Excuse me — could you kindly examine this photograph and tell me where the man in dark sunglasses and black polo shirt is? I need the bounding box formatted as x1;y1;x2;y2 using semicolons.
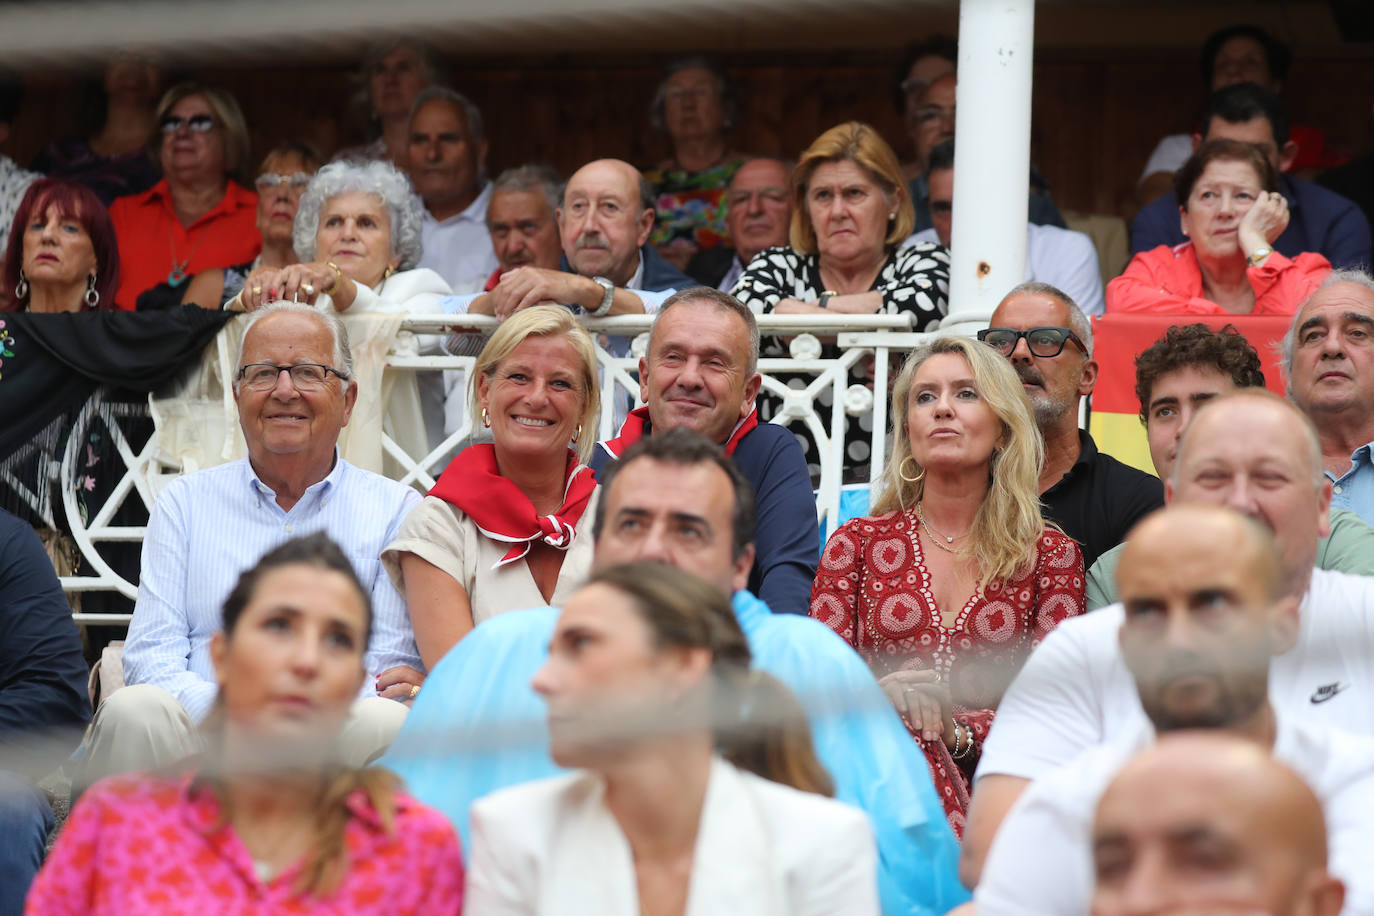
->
985;283;1164;567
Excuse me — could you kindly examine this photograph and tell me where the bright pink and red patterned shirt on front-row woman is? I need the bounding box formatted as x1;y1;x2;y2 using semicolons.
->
25;775;463;916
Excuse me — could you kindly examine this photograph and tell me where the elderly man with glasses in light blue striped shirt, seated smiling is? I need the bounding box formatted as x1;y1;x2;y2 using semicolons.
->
76;302;423;788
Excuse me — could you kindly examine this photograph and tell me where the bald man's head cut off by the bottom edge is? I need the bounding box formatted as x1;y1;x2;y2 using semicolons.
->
1092;732;1345;916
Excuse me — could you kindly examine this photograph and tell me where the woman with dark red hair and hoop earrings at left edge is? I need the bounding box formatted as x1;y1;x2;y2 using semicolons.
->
0;179;120;312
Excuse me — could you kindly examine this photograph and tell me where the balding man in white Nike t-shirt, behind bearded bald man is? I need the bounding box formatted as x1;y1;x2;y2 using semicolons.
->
960;389;1374;887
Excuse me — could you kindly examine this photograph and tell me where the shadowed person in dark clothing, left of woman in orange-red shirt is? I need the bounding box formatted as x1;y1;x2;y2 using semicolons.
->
30;54;162;206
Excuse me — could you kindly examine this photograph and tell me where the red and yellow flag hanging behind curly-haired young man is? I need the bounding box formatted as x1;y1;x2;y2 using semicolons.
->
1088;314;1292;474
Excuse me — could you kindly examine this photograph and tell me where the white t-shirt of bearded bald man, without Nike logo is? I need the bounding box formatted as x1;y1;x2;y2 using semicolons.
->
974;700;1374;916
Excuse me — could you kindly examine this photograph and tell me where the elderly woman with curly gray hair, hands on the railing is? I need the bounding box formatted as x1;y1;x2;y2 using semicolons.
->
239;162;452;313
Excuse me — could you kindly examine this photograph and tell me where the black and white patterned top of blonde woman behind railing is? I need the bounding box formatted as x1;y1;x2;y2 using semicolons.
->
731;242;949;483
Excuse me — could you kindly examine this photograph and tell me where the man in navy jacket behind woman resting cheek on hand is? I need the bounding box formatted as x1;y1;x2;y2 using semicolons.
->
1131;82;1370;269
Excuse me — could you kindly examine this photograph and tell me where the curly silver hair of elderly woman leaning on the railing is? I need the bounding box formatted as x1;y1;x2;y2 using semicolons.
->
291;161;425;271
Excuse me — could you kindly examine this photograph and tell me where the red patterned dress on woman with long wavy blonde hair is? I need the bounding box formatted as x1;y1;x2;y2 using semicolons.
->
811;512;1085;838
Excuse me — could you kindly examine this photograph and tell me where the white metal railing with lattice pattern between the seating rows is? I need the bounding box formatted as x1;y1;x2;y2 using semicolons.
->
45;314;934;623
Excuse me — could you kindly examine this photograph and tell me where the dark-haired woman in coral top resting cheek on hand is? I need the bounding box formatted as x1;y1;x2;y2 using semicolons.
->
1106;140;1331;314
